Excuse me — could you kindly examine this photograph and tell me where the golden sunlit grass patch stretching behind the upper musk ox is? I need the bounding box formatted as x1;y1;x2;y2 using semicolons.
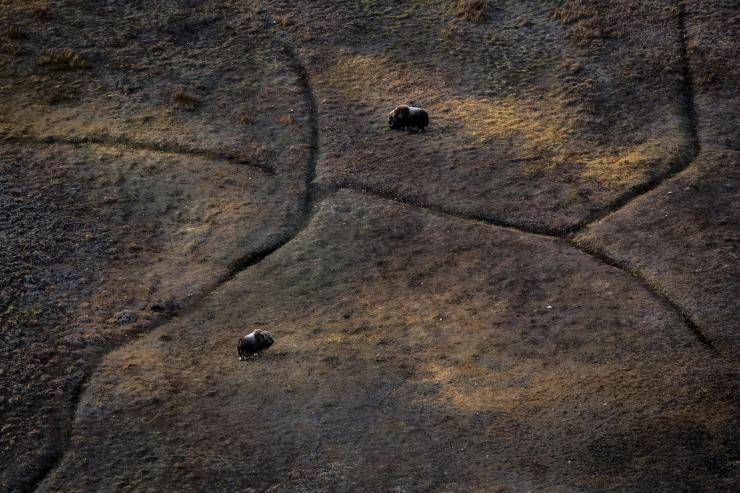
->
321;54;689;189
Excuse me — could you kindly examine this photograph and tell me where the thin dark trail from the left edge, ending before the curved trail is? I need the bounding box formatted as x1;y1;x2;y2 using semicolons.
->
0;135;275;175
